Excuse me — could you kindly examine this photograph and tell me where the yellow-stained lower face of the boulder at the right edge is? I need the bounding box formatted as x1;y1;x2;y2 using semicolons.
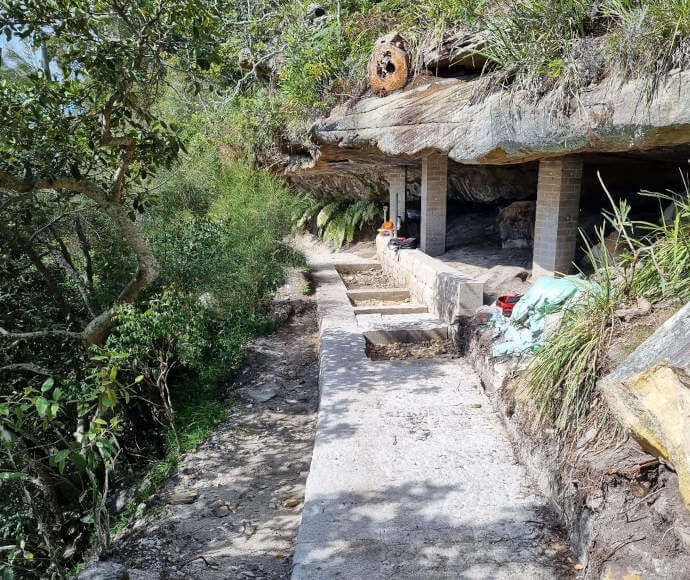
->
600;363;690;509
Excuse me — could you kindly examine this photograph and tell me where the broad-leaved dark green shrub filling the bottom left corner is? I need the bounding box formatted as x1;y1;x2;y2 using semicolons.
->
0;350;148;577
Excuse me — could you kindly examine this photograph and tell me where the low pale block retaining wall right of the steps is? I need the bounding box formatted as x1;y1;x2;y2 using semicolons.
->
376;236;483;324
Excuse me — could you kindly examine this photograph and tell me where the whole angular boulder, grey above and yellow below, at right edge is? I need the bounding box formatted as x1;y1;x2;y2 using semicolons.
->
599;304;690;509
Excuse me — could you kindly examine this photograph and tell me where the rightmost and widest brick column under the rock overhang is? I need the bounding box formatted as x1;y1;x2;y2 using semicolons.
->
532;157;582;278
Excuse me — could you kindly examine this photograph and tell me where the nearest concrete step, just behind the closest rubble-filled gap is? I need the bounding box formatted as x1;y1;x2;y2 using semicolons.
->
356;314;449;344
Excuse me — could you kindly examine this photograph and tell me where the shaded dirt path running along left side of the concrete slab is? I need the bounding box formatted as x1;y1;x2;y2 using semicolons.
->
109;284;318;579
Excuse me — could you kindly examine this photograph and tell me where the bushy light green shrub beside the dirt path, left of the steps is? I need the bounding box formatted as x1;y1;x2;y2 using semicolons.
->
100;153;304;540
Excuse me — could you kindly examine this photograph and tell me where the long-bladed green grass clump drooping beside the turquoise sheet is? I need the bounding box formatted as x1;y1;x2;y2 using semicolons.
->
520;178;690;434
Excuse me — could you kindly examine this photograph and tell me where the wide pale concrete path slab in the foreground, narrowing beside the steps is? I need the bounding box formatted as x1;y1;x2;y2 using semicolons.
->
292;251;568;580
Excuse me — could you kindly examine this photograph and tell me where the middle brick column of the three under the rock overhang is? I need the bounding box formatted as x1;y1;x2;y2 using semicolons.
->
419;153;448;256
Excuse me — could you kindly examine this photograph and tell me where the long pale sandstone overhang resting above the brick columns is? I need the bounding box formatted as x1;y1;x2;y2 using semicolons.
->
296;71;690;174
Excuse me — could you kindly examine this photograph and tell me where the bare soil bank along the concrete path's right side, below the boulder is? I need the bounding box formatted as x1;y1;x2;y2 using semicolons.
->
463;309;690;580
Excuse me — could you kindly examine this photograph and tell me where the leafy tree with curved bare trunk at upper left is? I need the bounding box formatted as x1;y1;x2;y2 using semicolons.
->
0;0;220;343
